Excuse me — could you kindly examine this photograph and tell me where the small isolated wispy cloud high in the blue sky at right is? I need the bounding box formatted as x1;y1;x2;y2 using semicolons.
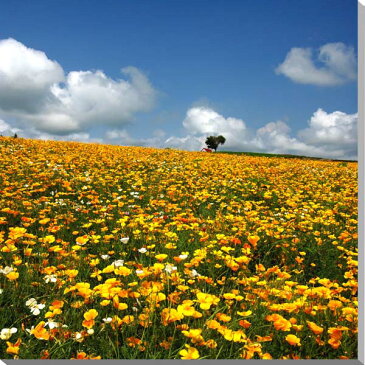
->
275;42;357;86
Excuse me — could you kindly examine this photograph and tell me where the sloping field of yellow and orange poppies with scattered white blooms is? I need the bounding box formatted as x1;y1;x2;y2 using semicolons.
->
0;137;358;359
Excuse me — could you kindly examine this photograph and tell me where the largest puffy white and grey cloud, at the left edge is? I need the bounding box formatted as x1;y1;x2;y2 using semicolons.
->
0;39;156;135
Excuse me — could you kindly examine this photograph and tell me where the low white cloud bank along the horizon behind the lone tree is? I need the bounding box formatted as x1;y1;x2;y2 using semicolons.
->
163;107;357;159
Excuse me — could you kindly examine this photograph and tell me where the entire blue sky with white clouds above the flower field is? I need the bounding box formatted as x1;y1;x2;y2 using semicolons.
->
0;0;357;159
